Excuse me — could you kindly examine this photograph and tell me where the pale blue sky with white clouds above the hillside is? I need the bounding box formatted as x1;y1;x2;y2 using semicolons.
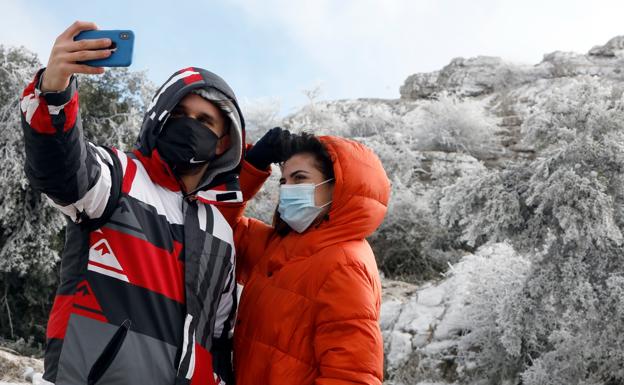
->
0;0;624;115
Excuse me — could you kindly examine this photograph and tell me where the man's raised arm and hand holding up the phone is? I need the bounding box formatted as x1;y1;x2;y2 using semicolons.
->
20;22;118;222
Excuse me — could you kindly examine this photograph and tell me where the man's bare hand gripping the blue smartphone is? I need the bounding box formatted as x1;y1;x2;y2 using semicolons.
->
41;21;112;92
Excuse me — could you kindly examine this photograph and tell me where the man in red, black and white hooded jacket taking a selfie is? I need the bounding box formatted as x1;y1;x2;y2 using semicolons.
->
21;22;244;385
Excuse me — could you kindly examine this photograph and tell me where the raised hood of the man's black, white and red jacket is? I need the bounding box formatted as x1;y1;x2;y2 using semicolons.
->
136;67;245;189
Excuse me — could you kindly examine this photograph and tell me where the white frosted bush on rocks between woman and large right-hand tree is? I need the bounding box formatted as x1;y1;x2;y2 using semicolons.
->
449;243;531;385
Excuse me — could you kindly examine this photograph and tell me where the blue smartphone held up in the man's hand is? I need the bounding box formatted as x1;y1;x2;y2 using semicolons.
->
74;30;134;67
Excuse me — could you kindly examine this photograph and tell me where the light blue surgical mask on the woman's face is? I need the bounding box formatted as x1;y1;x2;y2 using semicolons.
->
277;178;333;233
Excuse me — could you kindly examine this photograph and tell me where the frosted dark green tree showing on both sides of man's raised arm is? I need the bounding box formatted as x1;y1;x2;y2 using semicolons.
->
0;46;154;342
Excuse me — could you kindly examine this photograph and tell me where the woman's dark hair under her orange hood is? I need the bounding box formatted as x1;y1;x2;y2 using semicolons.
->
273;132;334;237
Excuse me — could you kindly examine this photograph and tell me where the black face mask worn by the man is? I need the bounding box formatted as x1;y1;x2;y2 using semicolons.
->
156;116;220;173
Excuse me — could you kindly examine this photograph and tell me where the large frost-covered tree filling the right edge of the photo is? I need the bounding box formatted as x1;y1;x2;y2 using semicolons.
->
440;77;624;385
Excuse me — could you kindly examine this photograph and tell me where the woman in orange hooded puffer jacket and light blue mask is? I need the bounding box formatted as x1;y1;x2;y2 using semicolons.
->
224;128;390;385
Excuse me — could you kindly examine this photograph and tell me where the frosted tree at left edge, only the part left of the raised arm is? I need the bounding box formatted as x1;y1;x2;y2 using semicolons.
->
0;46;63;344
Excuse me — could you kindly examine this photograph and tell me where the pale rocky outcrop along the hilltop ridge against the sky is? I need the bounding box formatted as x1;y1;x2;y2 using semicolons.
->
400;36;624;167
